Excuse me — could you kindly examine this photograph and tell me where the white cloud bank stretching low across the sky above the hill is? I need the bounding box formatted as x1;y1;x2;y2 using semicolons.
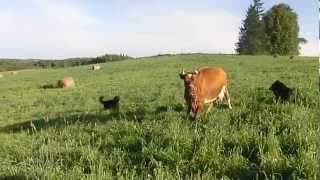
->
0;0;318;58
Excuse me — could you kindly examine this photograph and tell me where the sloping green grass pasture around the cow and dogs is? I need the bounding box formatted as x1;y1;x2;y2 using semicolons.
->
0;54;319;179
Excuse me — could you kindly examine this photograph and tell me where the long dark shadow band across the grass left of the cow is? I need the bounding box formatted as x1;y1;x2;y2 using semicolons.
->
0;103;238;134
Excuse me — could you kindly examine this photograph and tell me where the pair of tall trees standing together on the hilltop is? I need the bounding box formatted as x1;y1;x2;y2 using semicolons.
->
236;0;307;56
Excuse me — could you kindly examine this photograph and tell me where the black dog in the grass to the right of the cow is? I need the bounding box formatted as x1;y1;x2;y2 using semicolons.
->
269;80;293;101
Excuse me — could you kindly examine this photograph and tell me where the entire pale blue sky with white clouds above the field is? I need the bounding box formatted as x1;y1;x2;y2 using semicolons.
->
0;0;319;59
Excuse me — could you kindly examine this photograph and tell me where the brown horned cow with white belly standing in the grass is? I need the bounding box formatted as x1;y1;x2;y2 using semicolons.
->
179;67;232;118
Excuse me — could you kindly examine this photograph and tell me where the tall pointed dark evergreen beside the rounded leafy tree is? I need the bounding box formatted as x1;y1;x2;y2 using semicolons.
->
236;0;266;54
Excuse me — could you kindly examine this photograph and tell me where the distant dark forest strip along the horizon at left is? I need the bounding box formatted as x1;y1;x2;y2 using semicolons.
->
0;54;133;72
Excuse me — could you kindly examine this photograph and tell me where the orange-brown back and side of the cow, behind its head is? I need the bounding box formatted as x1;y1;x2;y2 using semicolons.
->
196;67;228;99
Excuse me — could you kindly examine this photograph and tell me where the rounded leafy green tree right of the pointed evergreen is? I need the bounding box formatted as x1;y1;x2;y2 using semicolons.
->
263;4;299;55
